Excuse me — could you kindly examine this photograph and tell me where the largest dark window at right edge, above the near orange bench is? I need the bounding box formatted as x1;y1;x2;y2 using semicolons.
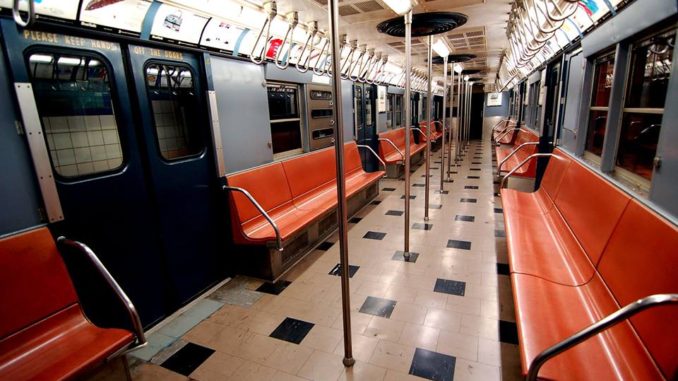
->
615;29;676;184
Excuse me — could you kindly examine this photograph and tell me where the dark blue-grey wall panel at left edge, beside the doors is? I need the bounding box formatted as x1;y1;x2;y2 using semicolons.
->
0;40;41;236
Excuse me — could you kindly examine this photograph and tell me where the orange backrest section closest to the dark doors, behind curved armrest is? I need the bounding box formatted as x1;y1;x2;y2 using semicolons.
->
226;163;292;224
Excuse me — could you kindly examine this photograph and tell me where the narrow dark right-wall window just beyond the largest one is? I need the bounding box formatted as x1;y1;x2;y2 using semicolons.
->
585;53;614;156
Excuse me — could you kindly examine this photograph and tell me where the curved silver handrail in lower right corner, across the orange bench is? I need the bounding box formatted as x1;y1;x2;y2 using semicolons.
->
526;294;678;381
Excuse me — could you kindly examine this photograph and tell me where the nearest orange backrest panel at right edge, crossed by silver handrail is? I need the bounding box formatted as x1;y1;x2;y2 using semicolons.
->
598;200;678;380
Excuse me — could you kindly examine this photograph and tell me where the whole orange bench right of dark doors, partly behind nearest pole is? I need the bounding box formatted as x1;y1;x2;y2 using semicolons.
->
227;142;384;244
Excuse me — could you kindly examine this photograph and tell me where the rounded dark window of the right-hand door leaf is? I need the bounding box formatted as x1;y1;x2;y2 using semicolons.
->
146;63;203;160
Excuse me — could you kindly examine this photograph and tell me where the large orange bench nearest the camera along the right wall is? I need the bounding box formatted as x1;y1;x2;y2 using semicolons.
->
501;149;678;380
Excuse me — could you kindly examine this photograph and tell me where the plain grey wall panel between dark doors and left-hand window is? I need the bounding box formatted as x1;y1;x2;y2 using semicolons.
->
211;56;273;173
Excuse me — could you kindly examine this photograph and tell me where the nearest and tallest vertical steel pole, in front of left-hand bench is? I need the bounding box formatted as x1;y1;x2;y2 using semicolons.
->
327;0;355;367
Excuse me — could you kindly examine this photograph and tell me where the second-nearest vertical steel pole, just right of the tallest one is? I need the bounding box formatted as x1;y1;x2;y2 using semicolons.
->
404;11;412;255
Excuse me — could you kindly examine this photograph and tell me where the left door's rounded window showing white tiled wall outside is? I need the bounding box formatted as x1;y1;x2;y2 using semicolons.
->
28;52;123;177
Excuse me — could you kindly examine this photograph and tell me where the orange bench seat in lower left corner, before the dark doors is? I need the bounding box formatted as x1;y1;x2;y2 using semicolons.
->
0;227;134;380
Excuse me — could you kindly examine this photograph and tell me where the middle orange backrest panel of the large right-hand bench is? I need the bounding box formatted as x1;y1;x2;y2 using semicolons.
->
554;160;630;265
